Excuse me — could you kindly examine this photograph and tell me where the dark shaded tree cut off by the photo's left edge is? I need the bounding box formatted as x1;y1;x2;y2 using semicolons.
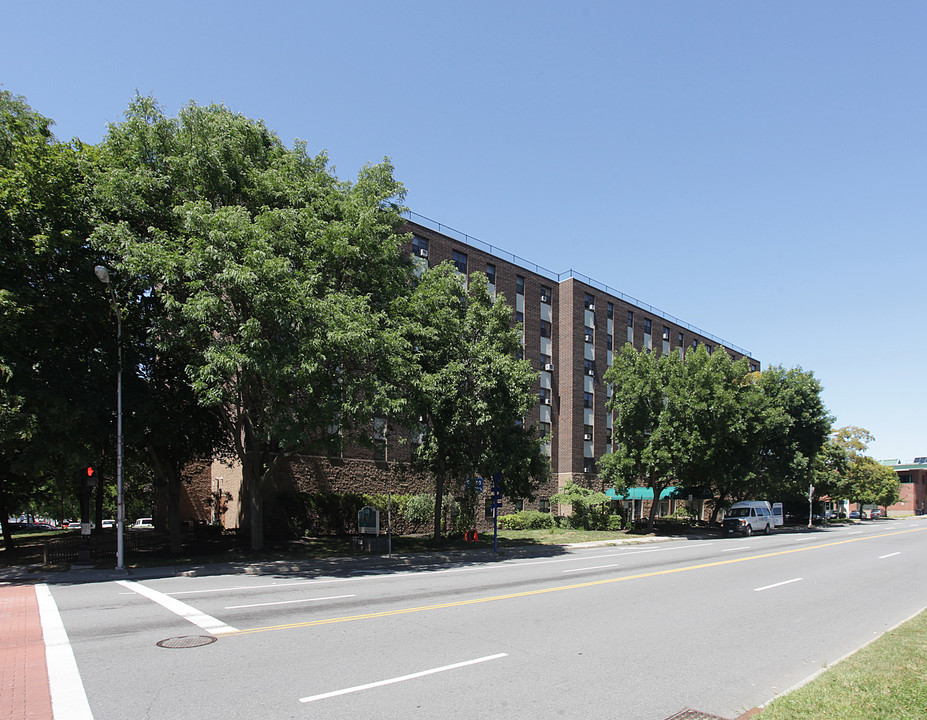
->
0;91;109;541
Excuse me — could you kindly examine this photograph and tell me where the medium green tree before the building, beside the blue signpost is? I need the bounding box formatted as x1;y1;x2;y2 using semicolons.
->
402;263;550;541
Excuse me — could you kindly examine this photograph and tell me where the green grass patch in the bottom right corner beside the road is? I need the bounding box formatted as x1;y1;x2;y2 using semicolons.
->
759;611;927;720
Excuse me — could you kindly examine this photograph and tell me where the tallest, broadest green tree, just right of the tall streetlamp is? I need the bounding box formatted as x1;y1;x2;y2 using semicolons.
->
96;98;411;549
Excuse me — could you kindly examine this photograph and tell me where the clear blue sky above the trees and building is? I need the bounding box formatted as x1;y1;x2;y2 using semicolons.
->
0;0;927;460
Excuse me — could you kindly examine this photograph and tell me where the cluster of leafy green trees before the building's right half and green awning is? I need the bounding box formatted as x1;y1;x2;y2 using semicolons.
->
600;344;830;524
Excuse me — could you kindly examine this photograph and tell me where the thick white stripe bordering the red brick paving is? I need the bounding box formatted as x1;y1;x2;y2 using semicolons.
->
35;583;93;720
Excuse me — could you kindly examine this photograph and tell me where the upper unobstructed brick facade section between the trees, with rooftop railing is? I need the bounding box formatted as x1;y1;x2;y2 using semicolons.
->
408;214;760;510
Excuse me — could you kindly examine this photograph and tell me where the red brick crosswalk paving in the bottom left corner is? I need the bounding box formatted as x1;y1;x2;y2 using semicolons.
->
0;584;53;720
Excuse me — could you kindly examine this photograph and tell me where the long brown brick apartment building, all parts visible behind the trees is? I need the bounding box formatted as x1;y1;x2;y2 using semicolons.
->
203;213;759;527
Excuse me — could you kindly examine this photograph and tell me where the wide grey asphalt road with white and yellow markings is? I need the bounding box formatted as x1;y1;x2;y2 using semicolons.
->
50;518;927;720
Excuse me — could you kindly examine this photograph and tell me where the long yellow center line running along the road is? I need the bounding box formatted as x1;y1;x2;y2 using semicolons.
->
214;528;927;637
